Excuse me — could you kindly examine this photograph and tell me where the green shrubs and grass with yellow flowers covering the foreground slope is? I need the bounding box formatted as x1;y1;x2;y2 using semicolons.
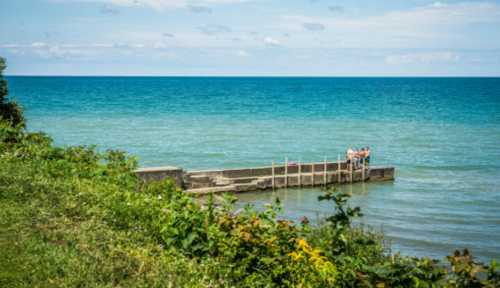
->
0;58;500;287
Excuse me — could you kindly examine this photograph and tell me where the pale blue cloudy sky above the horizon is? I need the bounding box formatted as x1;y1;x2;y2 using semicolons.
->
0;0;500;76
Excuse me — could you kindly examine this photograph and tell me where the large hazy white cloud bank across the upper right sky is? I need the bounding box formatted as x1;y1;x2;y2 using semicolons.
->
280;2;500;50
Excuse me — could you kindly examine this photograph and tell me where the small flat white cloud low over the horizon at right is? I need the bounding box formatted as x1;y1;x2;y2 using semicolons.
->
385;51;460;65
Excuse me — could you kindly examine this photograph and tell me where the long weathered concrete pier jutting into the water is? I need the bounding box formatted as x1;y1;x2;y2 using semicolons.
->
137;162;395;195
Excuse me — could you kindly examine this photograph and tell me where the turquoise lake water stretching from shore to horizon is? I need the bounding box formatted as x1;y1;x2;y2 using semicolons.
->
8;77;500;260
